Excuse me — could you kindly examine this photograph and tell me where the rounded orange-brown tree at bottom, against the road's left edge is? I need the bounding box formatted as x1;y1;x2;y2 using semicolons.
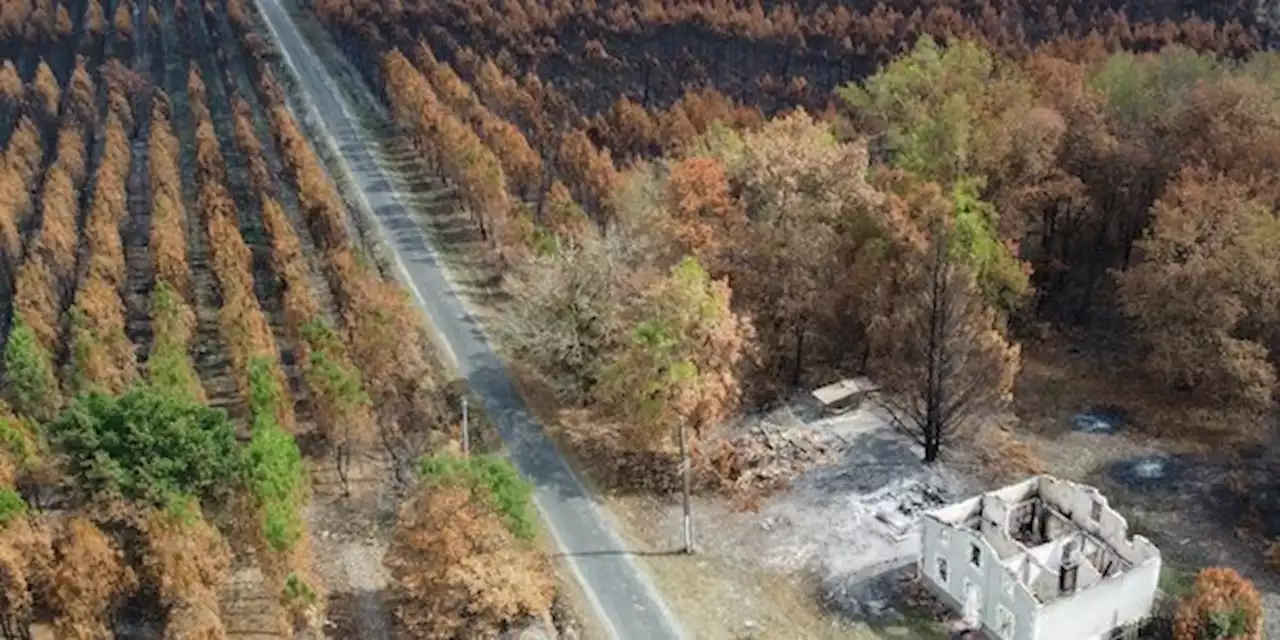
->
384;486;554;639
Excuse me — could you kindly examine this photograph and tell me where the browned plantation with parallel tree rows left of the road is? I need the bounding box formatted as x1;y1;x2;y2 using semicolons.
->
0;0;529;639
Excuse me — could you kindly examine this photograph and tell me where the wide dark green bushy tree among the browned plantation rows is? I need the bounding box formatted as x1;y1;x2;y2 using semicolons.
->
50;388;241;507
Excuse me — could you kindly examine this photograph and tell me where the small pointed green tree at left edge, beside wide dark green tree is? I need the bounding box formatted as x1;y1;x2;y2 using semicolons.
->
4;314;60;420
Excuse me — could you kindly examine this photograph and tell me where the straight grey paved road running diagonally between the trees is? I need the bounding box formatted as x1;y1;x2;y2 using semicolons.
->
250;0;684;640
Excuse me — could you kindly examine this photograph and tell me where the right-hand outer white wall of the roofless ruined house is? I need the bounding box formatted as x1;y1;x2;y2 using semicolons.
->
1034;557;1160;640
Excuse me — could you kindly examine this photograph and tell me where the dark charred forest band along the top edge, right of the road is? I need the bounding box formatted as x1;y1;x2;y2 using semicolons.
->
315;0;1274;120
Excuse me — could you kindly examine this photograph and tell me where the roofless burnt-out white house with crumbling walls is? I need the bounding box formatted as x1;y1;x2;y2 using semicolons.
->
918;476;1160;640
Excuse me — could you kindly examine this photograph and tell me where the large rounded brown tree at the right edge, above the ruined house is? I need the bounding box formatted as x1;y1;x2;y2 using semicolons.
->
1119;172;1280;408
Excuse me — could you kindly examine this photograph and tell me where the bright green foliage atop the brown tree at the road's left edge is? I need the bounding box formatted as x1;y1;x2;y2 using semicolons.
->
417;453;538;540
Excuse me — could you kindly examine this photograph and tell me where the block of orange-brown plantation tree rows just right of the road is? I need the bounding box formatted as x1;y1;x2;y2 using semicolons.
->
380;41;763;243
